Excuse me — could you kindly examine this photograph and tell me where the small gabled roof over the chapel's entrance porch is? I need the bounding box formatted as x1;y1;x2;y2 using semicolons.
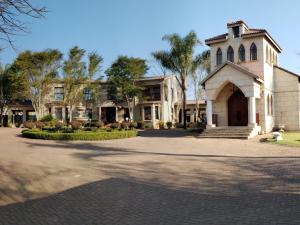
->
200;61;263;85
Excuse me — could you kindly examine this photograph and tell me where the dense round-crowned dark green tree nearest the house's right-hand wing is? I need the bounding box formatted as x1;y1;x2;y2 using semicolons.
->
106;56;148;120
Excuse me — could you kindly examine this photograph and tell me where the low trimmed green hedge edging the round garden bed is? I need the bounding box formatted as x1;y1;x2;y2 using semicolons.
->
22;129;138;141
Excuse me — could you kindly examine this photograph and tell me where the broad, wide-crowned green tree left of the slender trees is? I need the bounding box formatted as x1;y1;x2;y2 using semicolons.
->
8;49;62;120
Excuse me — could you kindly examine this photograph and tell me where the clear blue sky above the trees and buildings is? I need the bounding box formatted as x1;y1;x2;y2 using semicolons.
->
0;0;300;78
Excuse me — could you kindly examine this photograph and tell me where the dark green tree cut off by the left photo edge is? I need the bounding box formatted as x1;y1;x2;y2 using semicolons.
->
0;65;11;125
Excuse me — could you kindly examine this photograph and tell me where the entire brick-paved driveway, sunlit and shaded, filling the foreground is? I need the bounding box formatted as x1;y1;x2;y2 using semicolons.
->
0;129;300;225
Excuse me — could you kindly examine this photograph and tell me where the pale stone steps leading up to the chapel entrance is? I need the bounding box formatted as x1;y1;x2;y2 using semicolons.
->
199;126;260;139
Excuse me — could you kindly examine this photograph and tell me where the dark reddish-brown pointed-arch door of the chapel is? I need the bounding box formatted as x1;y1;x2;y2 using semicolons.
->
227;89;248;126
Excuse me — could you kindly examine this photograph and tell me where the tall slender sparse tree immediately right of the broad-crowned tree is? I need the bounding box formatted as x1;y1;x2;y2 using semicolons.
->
63;46;88;121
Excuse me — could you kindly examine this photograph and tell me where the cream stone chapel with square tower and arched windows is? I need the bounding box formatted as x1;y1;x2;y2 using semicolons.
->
201;21;300;136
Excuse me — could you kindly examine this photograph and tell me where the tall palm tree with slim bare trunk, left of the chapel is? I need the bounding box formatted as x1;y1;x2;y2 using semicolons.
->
153;31;201;129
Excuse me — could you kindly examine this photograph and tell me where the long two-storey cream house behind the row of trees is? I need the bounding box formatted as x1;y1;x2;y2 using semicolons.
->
5;75;181;128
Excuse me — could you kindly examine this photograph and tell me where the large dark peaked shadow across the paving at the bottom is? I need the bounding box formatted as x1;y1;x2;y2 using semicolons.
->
0;179;300;225
